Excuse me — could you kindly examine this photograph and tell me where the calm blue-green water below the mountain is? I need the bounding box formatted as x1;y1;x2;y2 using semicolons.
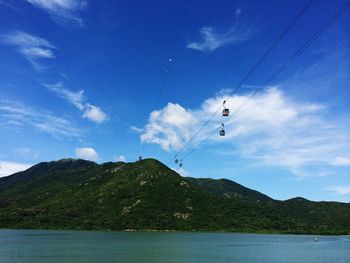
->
0;230;350;263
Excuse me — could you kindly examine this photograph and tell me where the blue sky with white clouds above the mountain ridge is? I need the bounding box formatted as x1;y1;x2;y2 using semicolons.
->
0;0;350;202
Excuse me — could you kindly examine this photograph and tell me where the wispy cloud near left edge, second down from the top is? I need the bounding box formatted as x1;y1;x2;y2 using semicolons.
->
0;31;55;70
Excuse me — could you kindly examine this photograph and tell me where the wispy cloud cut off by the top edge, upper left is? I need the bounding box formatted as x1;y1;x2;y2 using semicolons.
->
26;0;87;27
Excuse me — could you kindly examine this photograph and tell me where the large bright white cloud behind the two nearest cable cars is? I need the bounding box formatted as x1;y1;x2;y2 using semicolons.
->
141;88;350;176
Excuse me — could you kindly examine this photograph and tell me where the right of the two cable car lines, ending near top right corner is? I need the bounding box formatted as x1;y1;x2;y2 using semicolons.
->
178;0;350;163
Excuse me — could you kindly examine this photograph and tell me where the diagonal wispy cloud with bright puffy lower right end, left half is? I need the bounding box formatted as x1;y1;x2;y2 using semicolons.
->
44;82;109;123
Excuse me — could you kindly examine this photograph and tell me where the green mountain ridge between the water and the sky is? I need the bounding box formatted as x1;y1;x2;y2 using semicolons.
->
0;159;350;234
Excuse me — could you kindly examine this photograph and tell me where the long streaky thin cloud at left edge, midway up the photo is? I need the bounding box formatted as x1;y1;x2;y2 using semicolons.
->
0;100;80;138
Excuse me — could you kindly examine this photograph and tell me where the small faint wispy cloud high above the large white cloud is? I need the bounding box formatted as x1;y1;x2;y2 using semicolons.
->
187;27;250;52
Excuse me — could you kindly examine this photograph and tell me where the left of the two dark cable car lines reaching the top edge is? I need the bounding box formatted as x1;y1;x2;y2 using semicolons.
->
167;0;315;167
